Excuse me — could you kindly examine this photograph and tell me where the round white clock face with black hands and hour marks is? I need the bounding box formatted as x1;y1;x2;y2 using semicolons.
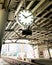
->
18;10;34;27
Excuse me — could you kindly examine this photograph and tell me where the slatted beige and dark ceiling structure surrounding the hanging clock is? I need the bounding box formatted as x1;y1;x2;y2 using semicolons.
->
0;0;52;44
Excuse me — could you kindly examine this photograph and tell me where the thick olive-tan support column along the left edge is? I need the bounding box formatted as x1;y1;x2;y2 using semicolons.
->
0;9;8;53
